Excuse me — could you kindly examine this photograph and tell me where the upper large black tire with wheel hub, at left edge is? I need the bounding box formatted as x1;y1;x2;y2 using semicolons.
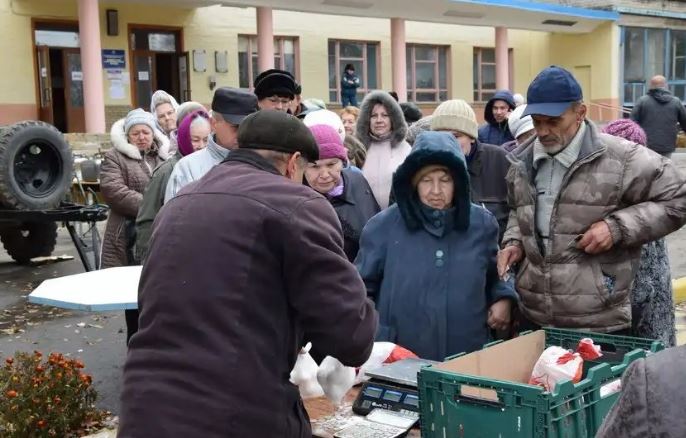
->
0;121;73;210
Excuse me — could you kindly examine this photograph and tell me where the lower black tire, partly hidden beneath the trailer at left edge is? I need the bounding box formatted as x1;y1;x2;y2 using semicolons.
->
0;222;57;264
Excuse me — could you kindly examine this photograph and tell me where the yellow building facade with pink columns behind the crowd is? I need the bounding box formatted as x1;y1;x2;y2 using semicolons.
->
0;0;636;132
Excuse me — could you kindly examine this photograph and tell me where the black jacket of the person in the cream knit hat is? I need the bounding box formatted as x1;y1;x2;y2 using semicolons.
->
467;141;510;242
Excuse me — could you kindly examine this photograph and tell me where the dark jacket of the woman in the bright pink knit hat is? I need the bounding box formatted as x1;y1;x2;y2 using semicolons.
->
331;169;381;262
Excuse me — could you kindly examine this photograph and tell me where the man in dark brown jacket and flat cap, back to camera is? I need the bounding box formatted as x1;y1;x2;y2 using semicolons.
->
118;110;377;438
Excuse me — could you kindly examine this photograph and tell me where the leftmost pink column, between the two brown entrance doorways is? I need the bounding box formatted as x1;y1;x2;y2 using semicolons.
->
79;0;106;133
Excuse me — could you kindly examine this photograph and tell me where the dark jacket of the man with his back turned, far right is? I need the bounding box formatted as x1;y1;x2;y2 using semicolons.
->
631;88;686;154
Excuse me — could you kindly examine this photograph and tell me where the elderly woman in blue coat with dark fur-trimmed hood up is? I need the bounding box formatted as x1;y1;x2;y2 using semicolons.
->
355;132;517;360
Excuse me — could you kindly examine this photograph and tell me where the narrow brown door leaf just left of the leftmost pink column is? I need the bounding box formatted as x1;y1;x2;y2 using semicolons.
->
63;49;86;132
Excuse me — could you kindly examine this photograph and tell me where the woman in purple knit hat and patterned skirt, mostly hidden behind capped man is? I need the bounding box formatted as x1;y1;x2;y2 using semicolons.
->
603;119;676;347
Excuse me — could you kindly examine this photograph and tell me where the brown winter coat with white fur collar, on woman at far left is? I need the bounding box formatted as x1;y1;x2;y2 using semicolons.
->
100;119;169;268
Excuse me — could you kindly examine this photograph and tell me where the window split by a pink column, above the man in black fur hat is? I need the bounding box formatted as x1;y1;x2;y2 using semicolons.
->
238;35;300;90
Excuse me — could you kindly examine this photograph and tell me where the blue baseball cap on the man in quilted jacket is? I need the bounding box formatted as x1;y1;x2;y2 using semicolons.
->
522;65;583;117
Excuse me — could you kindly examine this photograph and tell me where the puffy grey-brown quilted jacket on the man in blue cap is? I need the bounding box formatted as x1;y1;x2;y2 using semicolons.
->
503;121;686;332
